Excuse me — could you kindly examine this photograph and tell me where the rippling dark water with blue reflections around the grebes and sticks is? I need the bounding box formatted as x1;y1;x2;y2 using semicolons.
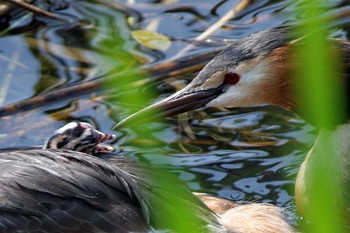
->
0;0;347;228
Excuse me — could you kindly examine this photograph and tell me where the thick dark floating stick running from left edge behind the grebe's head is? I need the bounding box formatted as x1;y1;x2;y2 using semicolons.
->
0;47;223;117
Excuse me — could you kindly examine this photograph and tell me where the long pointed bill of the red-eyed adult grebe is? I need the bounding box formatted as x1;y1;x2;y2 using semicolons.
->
113;86;223;129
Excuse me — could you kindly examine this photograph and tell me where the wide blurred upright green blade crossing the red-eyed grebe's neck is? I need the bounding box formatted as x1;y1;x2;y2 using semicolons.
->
295;0;345;233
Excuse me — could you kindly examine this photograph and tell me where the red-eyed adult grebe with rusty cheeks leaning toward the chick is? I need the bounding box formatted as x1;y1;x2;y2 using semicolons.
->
115;27;350;224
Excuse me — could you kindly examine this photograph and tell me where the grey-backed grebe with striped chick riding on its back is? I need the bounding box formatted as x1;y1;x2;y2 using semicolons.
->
0;122;293;233
